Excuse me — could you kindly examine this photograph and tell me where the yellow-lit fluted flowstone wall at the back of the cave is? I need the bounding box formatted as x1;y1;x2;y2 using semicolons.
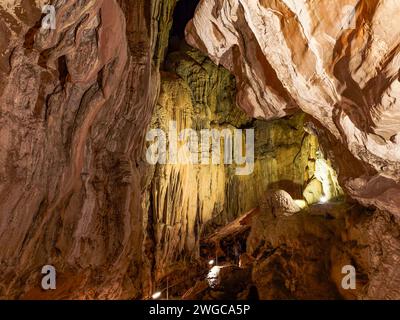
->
144;47;334;281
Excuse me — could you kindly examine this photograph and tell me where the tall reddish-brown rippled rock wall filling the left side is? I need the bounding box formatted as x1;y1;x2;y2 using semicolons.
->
0;0;179;298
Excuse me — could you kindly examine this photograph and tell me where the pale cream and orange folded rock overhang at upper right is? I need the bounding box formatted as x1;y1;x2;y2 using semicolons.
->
186;0;400;215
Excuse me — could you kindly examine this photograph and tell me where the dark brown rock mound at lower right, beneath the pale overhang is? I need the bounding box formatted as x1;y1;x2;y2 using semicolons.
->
247;203;400;299
